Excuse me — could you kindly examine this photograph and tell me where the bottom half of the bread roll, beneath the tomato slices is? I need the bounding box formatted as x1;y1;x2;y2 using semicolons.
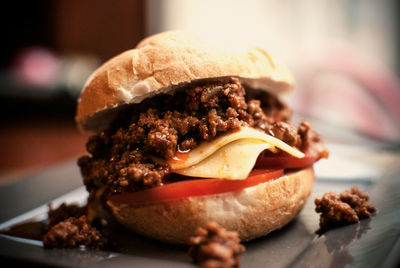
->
107;167;314;244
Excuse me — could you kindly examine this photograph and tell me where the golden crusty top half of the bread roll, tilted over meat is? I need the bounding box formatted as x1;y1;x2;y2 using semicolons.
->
75;31;294;132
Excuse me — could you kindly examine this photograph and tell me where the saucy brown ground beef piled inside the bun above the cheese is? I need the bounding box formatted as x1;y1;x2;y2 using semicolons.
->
78;78;325;194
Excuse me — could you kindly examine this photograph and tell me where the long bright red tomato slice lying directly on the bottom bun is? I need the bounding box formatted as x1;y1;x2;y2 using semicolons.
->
107;169;283;204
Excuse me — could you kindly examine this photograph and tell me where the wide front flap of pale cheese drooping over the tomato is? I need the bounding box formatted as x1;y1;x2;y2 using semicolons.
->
174;139;271;180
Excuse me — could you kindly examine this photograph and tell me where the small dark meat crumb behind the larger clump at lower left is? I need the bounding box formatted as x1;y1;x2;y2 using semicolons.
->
48;203;87;227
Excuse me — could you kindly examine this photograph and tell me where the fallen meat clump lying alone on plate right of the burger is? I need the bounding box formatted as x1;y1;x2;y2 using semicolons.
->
315;186;376;232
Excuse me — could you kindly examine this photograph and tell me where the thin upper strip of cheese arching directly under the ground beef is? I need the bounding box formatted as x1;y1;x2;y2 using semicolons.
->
168;127;304;173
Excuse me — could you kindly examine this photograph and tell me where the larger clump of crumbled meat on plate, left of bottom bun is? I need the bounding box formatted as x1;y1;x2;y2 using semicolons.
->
43;216;106;249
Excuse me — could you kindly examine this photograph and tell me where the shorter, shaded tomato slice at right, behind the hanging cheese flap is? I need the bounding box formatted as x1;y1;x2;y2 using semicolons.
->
255;155;321;169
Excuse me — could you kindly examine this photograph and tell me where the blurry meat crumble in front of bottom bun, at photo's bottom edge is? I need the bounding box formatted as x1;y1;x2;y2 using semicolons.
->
189;222;245;268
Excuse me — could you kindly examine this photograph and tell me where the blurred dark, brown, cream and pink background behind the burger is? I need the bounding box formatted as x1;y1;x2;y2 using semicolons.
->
0;0;400;183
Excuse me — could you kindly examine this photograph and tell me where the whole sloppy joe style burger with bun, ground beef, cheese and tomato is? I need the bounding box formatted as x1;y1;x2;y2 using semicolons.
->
76;31;328;244
